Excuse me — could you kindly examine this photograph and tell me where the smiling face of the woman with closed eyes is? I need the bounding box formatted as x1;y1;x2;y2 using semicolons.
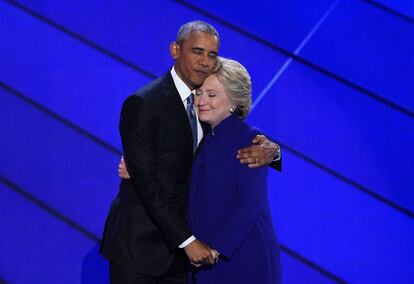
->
194;74;231;128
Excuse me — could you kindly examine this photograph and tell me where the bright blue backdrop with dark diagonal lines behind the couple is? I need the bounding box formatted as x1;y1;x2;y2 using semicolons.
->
0;0;414;283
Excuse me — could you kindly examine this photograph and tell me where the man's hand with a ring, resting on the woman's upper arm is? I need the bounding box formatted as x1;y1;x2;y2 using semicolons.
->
237;135;279;168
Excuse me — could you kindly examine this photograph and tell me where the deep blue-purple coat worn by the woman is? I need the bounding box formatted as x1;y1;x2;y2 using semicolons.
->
188;114;280;284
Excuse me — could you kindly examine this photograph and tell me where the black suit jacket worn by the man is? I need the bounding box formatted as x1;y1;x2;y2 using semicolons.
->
101;72;193;276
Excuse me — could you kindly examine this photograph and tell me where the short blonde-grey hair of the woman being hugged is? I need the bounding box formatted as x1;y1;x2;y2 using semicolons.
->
214;57;252;119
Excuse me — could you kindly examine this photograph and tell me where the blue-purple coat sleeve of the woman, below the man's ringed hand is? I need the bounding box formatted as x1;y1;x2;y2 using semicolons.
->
211;130;268;258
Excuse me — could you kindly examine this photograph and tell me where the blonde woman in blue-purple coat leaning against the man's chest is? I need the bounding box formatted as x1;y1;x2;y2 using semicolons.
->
188;58;280;284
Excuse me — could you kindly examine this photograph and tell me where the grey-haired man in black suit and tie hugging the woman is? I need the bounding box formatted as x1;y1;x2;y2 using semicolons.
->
101;21;282;283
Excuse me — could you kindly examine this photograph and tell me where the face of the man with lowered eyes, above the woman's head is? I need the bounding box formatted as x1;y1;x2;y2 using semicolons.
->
170;32;218;90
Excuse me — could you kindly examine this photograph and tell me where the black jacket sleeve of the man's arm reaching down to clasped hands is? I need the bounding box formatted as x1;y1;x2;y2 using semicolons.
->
119;96;192;249
